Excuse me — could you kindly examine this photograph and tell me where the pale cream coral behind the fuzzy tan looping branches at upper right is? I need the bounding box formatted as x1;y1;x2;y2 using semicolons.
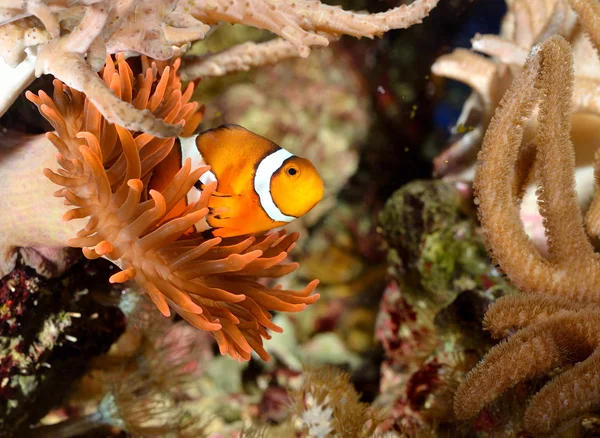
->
432;0;600;251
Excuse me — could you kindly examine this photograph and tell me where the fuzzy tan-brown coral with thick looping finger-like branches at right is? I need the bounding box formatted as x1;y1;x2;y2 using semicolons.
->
455;36;600;435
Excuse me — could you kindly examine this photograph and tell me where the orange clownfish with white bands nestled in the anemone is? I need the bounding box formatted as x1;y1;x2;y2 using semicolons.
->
150;124;324;237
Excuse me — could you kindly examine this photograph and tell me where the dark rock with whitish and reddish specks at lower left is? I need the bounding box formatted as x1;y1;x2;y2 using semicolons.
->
0;262;125;437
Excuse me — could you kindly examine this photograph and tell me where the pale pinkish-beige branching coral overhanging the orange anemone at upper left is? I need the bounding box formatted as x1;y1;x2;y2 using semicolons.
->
0;0;438;137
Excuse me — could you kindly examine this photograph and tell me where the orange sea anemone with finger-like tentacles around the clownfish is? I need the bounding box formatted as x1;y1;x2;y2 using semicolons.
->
3;55;319;360
